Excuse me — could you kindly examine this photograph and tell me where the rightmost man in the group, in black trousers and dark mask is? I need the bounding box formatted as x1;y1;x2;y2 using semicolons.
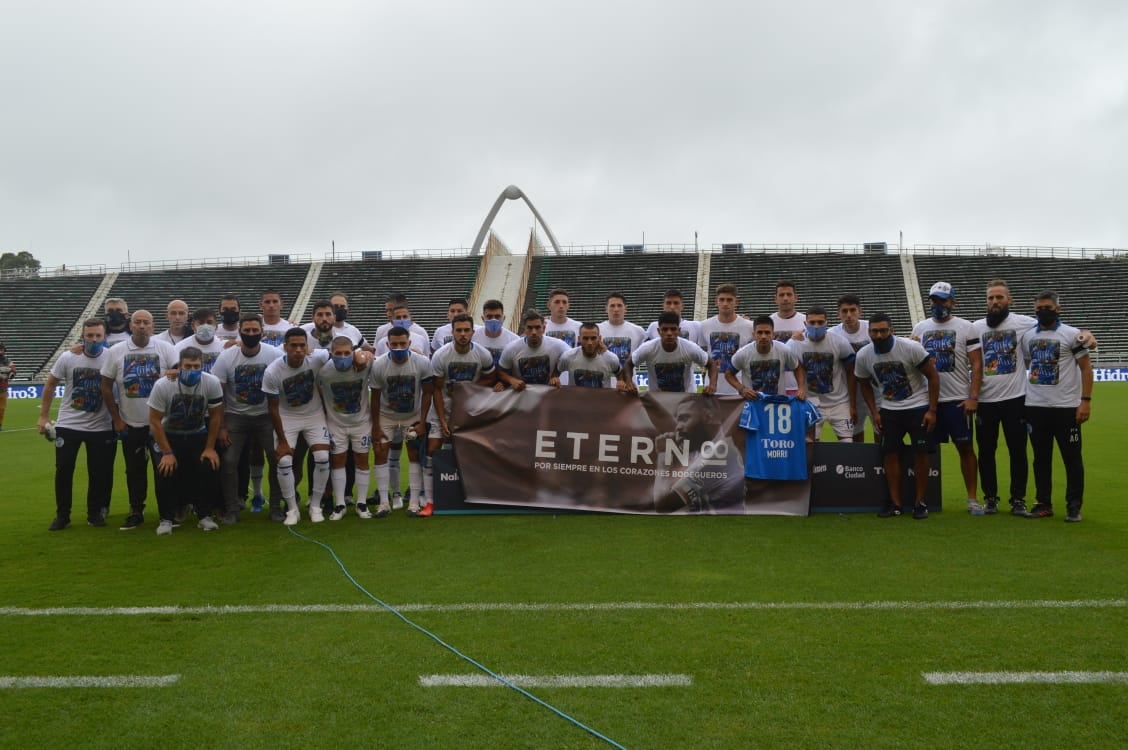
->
1022;291;1093;523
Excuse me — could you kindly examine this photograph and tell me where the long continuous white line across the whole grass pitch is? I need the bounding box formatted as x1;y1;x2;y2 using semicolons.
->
0;599;1128;617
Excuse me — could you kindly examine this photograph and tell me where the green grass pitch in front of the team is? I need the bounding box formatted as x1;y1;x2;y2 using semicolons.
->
0;383;1128;750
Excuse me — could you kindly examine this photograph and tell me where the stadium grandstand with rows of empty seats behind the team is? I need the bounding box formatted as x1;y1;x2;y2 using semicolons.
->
0;242;1128;381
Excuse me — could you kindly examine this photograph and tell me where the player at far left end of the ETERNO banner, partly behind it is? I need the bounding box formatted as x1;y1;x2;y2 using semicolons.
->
420;315;497;515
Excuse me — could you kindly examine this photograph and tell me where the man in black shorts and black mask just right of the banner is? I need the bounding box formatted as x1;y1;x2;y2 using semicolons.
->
854;312;940;520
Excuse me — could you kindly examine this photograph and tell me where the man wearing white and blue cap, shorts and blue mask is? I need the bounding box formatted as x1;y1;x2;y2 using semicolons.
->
913;281;984;515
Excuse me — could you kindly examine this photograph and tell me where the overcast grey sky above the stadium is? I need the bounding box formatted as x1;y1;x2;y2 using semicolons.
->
0;0;1128;267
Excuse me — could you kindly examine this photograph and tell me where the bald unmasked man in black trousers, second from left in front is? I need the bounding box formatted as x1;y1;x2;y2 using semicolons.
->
102;310;176;531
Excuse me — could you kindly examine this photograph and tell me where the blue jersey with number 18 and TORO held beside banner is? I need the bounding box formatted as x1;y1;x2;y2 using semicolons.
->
740;394;822;479
